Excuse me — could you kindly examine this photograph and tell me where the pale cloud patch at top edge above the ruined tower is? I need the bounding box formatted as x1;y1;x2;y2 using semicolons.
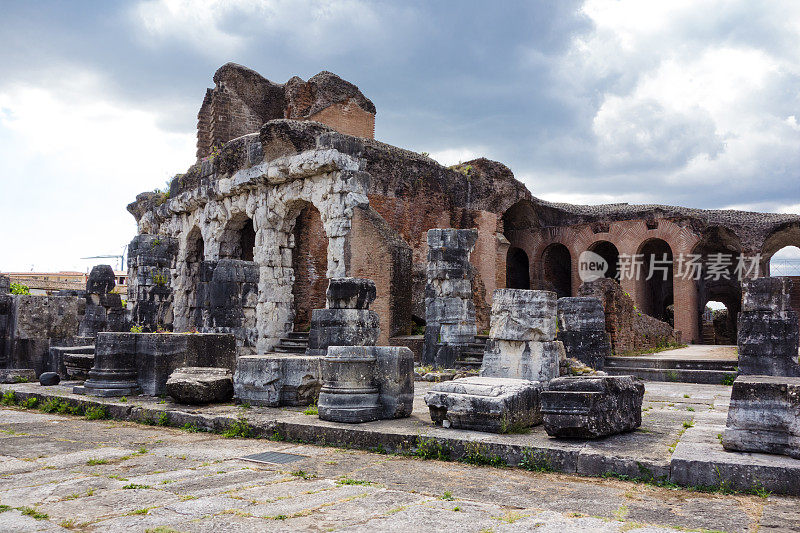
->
133;0;383;57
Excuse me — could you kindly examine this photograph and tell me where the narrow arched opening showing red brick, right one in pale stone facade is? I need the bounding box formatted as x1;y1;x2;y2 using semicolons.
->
292;202;328;331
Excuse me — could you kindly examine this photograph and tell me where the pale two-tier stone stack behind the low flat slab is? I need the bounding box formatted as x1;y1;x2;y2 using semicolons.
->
481;289;565;383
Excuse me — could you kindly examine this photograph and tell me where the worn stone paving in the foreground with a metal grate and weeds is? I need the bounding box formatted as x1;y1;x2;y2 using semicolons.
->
0;408;800;533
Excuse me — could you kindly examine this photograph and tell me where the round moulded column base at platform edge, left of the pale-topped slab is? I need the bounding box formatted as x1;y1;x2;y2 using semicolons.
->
318;346;382;423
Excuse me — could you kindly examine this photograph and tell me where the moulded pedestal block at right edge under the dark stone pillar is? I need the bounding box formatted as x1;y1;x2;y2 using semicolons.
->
722;376;800;459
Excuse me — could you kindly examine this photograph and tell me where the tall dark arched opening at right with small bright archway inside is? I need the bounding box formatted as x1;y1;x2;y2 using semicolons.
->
685;226;742;343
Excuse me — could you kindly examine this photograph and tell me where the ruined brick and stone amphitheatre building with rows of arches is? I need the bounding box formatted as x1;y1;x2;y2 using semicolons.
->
129;64;800;353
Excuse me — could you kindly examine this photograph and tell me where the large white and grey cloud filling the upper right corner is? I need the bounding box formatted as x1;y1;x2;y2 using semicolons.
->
559;0;800;205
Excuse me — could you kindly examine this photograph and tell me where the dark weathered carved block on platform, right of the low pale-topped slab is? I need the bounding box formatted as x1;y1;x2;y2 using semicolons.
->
541;376;644;439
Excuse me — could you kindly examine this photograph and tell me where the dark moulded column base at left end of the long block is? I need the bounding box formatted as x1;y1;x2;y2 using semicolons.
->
72;332;142;396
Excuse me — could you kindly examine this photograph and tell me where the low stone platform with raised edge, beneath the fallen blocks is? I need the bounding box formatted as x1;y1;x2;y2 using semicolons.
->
0;382;800;495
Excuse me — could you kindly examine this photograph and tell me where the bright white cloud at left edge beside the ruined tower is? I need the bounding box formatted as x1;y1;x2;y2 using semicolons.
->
0;68;195;271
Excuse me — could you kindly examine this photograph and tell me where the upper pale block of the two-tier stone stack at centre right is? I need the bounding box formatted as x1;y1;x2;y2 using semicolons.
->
489;289;556;341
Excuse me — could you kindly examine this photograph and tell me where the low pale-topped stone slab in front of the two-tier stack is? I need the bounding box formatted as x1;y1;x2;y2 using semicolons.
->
425;377;542;433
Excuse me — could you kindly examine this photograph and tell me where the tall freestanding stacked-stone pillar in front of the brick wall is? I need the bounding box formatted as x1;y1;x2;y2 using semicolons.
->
422;229;478;368
